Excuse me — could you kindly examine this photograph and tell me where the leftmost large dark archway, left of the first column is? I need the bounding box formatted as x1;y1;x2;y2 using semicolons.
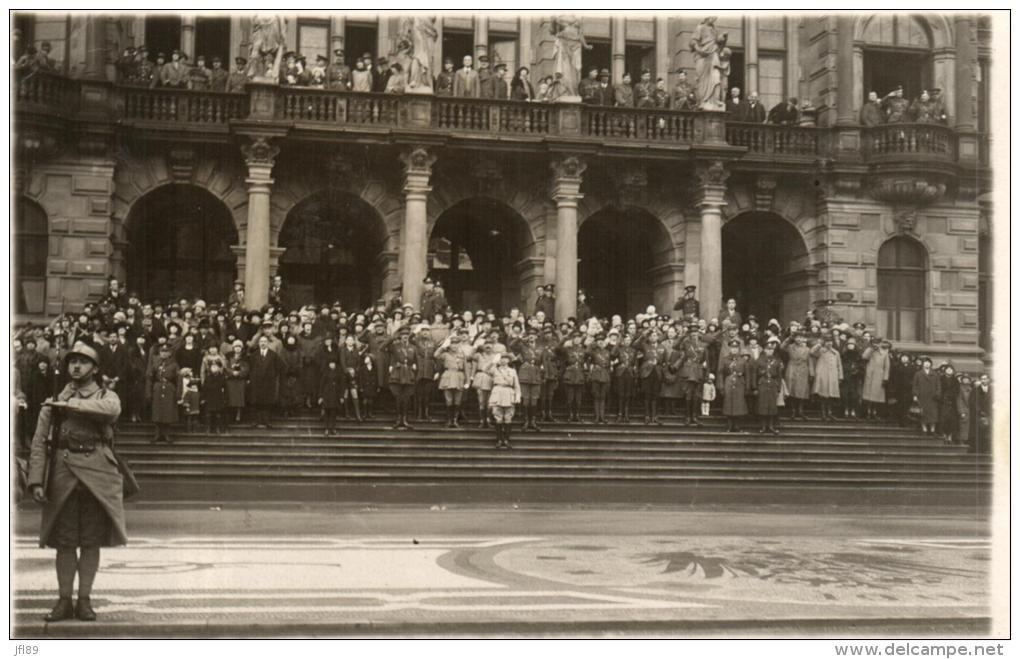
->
128;185;238;302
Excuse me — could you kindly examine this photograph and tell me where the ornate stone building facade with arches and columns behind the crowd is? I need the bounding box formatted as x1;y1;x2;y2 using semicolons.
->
12;14;991;364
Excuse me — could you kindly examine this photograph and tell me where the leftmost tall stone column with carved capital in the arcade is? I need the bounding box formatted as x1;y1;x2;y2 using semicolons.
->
241;137;279;309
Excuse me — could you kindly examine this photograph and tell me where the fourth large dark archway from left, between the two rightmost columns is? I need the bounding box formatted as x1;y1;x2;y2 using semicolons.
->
577;207;672;317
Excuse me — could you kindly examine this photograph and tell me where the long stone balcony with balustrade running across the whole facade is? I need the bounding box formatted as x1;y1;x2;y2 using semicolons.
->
15;71;987;180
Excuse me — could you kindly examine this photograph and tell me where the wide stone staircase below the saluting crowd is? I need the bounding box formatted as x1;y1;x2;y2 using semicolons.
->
117;413;991;505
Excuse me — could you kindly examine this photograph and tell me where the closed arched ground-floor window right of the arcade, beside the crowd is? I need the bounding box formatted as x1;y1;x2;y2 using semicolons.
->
878;237;928;341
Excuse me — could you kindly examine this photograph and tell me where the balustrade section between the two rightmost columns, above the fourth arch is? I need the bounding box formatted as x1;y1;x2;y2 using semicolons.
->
581;105;697;144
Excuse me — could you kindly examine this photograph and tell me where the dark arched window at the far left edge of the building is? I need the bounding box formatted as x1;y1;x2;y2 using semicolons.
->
14;198;50;313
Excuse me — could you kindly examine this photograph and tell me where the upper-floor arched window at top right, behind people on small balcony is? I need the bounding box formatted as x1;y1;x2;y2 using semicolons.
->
862;14;932;100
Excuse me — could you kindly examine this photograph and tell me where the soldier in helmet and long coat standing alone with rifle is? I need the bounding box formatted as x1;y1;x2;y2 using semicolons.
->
29;342;128;622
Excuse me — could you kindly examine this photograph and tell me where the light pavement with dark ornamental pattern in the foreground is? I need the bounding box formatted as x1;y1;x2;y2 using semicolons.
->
12;518;990;638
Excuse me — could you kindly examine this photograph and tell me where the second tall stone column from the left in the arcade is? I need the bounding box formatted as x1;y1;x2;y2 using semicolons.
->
400;147;436;309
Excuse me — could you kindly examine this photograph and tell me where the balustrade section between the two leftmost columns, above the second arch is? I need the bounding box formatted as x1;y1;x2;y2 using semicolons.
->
276;87;400;126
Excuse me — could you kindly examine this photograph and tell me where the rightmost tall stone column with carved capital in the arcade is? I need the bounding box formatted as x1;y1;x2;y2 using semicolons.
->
697;160;729;318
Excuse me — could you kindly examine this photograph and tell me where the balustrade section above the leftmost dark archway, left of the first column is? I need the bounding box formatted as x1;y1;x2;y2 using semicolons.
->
121;87;248;124
